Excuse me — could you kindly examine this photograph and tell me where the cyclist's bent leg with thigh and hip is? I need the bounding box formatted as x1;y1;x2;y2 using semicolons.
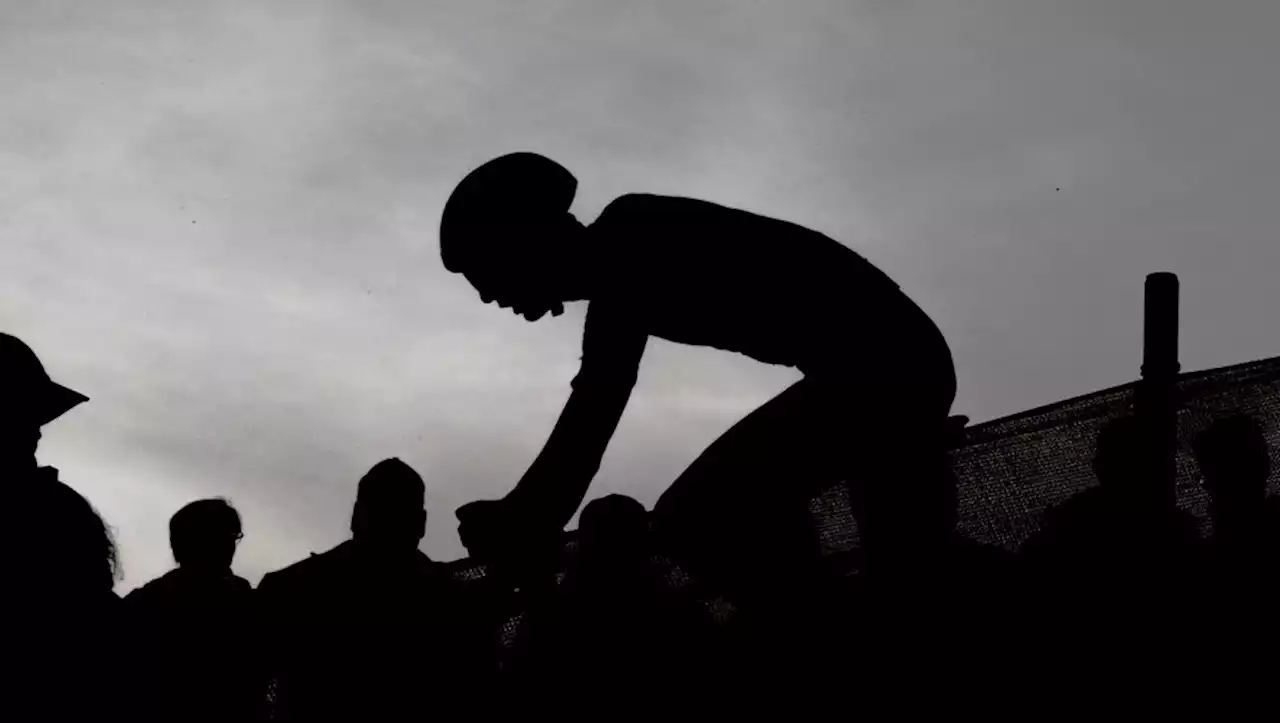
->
654;297;956;598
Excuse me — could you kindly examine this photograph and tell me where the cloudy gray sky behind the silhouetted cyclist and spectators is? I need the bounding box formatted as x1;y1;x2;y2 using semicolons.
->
0;0;1280;590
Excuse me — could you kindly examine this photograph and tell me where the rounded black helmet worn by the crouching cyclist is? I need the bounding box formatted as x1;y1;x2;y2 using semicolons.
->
440;151;577;273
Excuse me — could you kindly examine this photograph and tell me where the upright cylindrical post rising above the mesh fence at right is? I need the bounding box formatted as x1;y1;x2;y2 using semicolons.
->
1137;271;1180;504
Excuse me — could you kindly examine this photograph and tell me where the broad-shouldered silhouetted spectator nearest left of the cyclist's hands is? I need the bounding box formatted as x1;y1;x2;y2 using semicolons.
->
259;459;486;720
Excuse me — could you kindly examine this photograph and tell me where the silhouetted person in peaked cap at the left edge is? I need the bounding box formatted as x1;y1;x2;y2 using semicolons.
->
0;334;120;720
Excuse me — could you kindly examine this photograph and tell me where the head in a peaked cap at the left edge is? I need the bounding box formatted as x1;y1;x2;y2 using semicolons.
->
0;334;88;468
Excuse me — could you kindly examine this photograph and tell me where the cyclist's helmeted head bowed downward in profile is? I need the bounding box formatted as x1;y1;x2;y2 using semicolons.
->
440;152;584;321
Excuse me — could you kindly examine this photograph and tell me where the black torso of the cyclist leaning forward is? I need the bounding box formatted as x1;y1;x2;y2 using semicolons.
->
589;195;905;369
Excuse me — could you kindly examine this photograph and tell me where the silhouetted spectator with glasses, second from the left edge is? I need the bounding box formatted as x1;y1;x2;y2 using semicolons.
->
124;499;266;720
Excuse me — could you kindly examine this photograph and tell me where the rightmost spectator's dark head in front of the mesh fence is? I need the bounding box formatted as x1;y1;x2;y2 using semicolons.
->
1192;415;1271;504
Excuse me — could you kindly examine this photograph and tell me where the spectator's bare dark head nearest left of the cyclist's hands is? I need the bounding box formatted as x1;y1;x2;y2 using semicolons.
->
351;458;426;549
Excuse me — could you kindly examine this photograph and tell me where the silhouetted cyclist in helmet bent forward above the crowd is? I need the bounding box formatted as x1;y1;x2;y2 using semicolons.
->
440;152;956;591
